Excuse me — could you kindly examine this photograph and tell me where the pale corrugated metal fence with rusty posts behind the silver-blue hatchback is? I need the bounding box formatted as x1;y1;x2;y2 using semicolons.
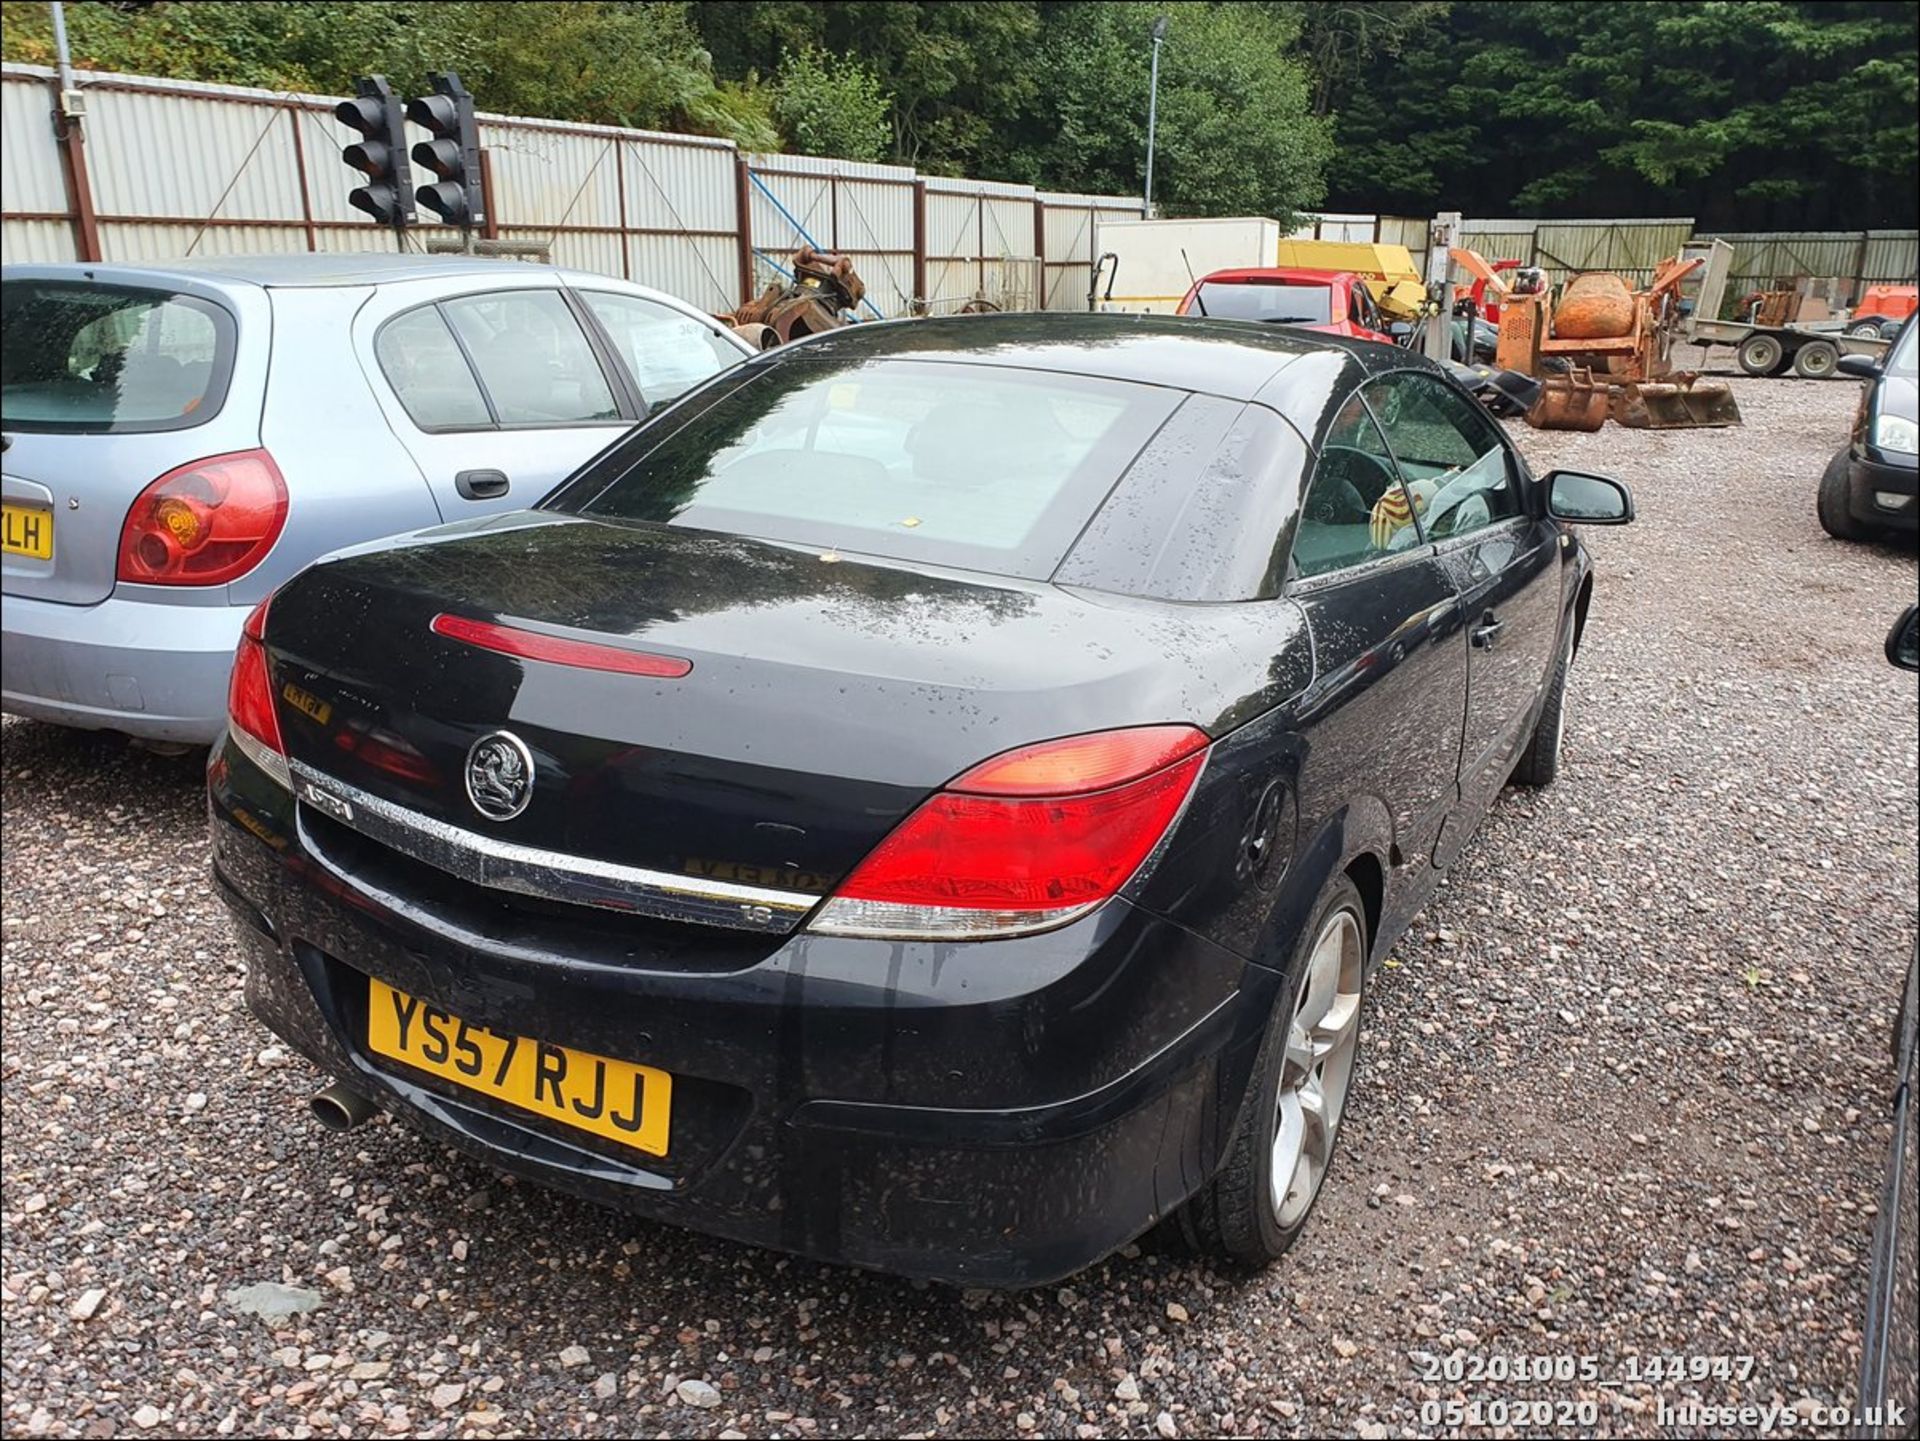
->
0;65;1139;315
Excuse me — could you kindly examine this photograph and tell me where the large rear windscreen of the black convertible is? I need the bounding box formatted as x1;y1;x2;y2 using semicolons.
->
543;355;1185;579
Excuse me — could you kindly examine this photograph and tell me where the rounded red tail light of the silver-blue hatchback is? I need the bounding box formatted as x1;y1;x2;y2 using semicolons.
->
115;451;286;585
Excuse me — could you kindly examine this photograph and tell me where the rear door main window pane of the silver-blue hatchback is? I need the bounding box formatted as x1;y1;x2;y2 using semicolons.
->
440;290;620;426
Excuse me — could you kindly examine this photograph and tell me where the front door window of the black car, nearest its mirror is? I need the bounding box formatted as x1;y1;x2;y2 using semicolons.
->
1367;374;1521;541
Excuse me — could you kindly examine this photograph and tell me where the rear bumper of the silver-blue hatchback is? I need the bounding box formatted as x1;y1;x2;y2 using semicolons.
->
0;595;246;744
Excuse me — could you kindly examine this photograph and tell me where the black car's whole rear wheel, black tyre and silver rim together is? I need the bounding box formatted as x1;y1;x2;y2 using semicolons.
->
1179;875;1367;1266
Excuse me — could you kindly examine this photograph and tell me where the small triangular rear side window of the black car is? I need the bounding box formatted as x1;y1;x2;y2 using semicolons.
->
1294;391;1421;576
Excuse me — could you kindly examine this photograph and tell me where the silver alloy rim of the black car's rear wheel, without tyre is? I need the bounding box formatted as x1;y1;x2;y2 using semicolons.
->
1269;908;1367;1228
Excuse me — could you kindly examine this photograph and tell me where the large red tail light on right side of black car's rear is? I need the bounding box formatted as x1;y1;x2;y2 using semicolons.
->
810;725;1208;940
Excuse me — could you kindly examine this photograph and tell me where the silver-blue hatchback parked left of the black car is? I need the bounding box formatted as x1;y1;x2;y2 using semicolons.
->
0;255;753;744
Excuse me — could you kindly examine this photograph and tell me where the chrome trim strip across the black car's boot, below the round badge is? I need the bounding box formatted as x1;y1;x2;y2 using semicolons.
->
292;760;820;934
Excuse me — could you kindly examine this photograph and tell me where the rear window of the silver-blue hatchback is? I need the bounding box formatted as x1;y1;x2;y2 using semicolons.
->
0;280;234;434
